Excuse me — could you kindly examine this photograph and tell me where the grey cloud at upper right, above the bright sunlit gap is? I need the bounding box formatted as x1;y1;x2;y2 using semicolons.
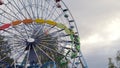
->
64;0;120;38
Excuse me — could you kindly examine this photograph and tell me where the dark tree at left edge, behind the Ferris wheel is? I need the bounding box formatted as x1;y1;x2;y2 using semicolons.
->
0;35;13;67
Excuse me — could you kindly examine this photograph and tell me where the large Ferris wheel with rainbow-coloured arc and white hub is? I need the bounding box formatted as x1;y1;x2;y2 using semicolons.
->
0;0;88;68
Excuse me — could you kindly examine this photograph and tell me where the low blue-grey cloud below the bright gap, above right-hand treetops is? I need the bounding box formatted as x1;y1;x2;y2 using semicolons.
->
82;39;120;68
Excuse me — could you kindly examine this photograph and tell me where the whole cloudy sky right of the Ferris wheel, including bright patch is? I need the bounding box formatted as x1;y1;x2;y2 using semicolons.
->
63;0;120;68
